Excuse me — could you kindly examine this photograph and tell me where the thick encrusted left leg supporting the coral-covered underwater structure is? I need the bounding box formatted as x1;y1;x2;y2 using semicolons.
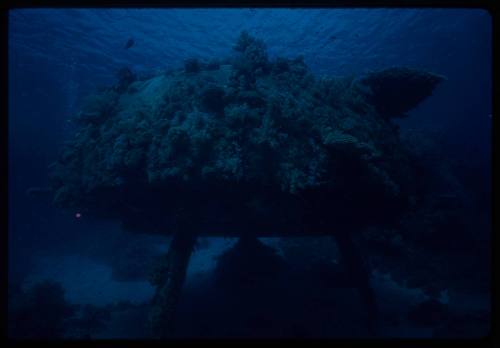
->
150;232;196;338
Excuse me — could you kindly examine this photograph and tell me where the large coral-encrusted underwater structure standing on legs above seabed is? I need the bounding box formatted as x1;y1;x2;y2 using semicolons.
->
51;32;444;337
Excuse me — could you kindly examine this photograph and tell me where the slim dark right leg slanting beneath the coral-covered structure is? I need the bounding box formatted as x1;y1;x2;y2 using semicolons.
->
335;231;379;334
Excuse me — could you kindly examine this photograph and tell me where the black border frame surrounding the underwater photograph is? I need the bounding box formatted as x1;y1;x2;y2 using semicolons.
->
0;0;500;347
